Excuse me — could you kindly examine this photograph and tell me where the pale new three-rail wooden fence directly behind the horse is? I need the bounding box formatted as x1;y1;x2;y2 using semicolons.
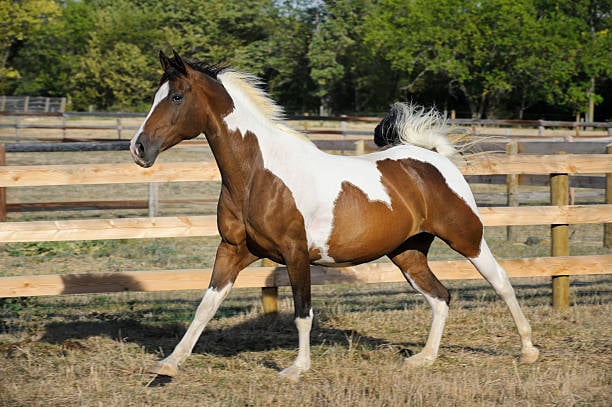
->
0;154;612;312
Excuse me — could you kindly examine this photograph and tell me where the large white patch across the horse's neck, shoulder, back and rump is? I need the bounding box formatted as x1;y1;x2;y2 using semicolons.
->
218;71;478;265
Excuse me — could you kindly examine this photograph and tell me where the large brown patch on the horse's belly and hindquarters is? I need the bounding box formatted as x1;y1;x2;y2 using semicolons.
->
329;159;482;264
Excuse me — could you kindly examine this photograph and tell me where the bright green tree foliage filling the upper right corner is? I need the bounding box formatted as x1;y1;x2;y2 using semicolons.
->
365;0;612;117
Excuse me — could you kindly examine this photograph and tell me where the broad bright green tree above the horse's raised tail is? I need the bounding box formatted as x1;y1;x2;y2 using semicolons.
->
366;0;548;117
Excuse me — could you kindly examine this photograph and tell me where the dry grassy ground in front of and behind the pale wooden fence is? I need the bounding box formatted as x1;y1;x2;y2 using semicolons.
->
0;135;612;407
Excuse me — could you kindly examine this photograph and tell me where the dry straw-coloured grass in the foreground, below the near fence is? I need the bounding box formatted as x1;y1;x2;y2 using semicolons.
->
0;277;612;407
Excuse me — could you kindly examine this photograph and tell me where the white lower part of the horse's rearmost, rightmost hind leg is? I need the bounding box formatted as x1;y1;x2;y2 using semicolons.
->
470;239;539;363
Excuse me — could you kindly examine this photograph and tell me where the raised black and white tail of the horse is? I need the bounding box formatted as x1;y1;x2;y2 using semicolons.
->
374;103;457;157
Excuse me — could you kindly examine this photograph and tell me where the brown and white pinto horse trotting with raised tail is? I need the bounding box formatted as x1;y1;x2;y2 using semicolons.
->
130;52;538;380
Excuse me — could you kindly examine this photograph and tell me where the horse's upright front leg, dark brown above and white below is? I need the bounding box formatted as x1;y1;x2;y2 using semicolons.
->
280;253;313;382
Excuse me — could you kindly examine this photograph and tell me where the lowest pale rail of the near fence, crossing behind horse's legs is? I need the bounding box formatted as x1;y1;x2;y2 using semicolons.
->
0;255;612;297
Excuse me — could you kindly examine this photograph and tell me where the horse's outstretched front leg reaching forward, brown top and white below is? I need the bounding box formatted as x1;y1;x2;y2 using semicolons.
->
150;242;257;377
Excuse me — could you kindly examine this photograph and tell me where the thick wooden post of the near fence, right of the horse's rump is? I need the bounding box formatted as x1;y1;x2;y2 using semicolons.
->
550;153;569;310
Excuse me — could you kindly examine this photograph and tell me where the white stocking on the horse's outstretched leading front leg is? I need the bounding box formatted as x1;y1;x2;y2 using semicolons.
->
151;283;232;376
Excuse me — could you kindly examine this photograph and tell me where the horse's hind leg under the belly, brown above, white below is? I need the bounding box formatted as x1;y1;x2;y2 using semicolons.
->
389;233;450;368
